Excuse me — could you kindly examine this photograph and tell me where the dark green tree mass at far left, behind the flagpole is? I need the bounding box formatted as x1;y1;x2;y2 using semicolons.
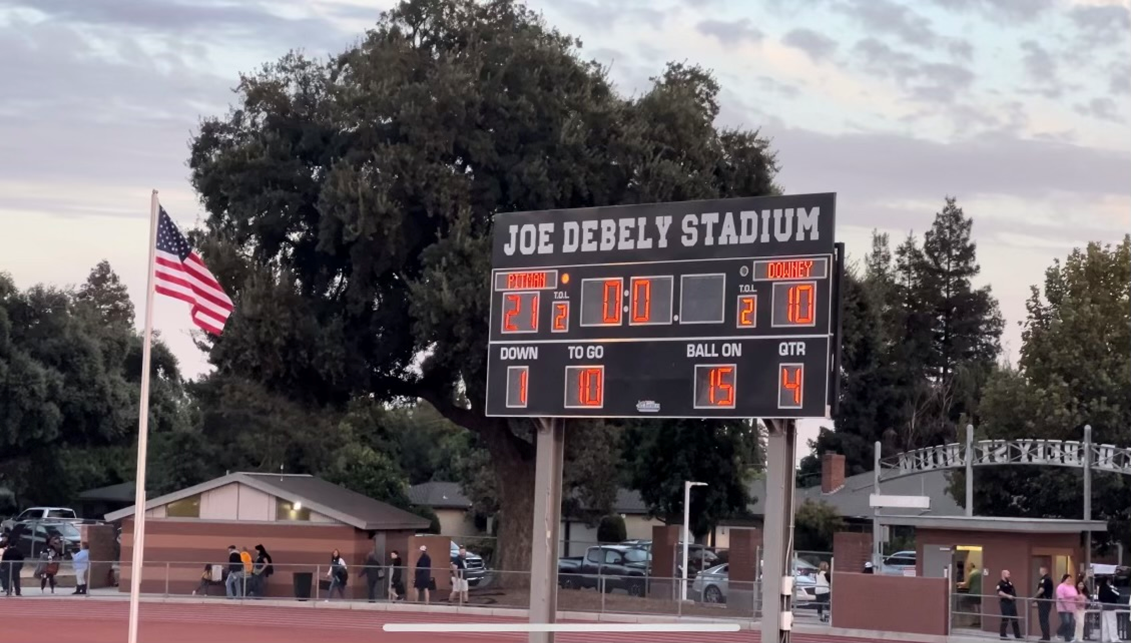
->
0;261;190;505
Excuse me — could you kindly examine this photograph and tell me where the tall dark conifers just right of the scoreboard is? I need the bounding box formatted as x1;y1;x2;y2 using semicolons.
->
802;198;1003;479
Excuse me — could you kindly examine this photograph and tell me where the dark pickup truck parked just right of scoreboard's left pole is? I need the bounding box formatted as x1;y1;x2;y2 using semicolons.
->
558;545;651;597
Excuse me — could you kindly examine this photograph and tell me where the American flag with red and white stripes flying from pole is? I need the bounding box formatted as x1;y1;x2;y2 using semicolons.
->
155;208;232;334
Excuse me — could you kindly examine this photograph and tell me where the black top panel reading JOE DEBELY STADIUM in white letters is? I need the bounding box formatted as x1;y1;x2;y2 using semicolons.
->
492;193;836;269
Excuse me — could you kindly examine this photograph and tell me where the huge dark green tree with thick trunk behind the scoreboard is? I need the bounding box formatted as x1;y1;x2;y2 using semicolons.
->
190;0;776;568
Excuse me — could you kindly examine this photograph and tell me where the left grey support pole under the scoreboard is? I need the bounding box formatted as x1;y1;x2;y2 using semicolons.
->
529;418;566;643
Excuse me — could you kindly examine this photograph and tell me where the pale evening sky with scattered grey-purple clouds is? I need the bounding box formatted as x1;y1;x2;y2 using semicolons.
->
0;0;1131;451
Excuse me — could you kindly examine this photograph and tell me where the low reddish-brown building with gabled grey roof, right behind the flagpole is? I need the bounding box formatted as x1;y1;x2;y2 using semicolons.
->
106;473;429;598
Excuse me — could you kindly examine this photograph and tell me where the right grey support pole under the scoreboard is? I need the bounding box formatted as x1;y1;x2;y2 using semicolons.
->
762;419;797;643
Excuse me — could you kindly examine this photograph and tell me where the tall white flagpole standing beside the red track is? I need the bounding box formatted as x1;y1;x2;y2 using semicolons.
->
128;190;161;643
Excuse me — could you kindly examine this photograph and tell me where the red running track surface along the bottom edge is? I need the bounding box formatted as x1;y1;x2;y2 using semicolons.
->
0;597;895;643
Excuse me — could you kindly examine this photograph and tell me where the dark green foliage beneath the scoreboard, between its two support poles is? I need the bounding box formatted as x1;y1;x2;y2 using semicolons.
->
624;419;763;536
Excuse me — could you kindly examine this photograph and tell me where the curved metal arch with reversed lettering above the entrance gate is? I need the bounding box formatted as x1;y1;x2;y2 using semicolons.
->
880;440;1131;481
